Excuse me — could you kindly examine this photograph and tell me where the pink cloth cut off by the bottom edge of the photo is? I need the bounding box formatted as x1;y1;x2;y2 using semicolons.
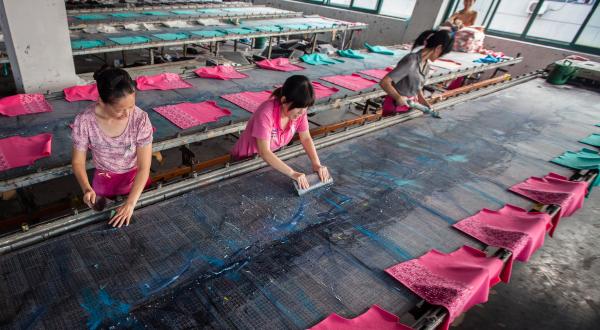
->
309;305;411;330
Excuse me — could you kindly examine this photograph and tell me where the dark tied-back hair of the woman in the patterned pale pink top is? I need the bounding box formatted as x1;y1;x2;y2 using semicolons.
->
94;64;135;104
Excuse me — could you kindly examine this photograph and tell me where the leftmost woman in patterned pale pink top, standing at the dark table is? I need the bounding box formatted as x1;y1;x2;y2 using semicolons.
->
72;66;152;227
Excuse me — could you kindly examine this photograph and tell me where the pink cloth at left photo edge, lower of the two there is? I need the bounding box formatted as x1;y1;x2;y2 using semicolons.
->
0;133;52;172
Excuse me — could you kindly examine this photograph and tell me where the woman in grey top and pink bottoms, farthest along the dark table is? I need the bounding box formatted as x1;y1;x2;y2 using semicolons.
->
379;30;452;117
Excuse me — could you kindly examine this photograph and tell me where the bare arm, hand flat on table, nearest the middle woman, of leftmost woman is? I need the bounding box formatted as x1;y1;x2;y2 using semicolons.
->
108;143;152;227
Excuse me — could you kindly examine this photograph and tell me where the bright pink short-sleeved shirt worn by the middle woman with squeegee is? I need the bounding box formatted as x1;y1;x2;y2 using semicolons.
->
231;98;309;159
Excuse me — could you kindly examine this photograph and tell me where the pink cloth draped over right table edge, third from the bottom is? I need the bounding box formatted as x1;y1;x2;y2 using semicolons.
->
453;204;552;283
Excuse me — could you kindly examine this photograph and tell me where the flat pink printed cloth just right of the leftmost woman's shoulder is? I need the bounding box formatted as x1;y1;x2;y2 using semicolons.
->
154;101;231;129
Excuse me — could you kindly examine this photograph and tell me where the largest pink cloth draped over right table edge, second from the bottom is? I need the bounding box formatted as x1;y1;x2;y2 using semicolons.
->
385;246;503;329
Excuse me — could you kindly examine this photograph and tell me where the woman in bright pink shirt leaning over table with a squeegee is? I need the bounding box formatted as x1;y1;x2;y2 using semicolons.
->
231;75;329;189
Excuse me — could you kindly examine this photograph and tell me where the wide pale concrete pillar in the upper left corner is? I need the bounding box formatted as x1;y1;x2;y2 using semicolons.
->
0;0;79;93
